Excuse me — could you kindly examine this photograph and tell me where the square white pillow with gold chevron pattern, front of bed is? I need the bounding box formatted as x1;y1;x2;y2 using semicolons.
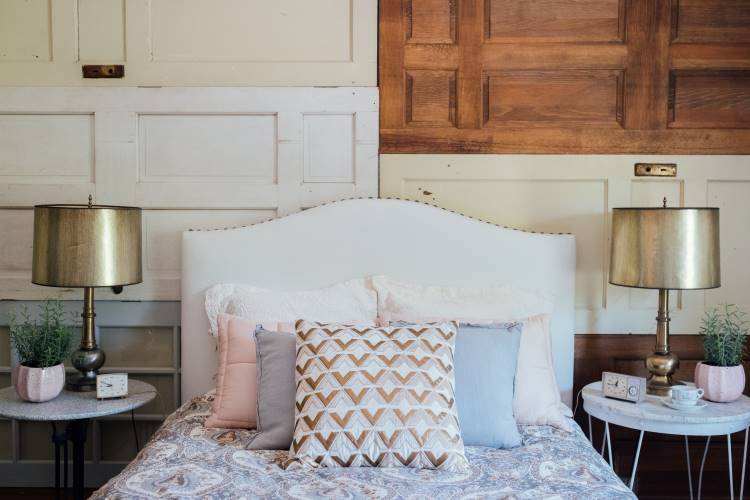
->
287;320;468;472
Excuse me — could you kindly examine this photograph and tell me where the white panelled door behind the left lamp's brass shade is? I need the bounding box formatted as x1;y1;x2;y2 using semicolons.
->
0;87;378;300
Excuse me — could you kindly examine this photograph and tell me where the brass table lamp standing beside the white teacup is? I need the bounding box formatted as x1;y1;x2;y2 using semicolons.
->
609;199;721;396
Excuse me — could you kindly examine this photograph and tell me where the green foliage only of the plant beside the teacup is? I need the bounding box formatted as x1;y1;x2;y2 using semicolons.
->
700;304;748;366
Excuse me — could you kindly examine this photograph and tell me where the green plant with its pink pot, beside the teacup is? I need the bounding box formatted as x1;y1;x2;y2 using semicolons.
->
695;305;748;403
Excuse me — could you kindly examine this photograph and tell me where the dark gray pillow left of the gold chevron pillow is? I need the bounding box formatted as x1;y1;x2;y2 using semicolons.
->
248;329;296;450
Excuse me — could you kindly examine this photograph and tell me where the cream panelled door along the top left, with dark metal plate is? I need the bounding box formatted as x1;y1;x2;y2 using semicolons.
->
0;0;378;86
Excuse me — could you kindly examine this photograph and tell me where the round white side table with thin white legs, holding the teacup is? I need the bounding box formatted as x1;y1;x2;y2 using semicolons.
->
582;382;750;500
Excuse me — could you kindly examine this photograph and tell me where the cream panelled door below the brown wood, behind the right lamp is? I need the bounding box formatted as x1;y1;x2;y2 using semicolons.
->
380;155;750;333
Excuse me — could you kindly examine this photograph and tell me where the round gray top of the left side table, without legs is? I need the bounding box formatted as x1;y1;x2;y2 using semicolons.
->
0;379;157;421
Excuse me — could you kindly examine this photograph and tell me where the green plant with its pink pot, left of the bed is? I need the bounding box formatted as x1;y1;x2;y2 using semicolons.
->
10;299;73;403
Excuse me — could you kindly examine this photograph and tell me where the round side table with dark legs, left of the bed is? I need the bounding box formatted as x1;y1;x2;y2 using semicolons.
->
0;379;157;499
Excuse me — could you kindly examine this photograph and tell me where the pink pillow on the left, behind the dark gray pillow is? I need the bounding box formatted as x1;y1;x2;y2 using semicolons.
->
206;314;294;429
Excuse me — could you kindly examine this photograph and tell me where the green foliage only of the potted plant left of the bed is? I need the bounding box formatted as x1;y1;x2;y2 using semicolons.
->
9;299;74;368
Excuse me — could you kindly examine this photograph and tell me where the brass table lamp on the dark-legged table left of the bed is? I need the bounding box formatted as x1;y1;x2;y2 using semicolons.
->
31;196;142;391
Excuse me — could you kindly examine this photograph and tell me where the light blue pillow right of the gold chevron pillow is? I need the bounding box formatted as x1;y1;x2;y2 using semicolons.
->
392;321;523;448
